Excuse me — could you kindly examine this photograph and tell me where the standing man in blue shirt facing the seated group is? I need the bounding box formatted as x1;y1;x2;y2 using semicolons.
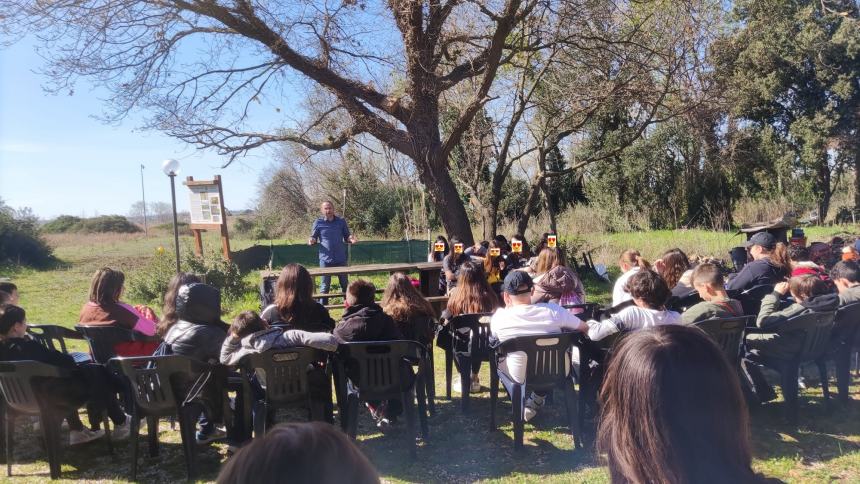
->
308;201;358;305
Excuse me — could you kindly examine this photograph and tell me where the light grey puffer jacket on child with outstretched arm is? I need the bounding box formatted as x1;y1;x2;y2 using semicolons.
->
221;328;337;366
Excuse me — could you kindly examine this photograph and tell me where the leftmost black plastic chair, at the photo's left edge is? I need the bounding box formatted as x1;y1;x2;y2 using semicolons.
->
0;361;113;479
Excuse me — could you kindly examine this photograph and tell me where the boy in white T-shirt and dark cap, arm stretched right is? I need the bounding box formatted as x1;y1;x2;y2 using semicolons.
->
490;271;588;421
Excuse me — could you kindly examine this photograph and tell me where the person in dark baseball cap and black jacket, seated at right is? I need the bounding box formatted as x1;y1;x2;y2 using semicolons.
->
726;232;790;291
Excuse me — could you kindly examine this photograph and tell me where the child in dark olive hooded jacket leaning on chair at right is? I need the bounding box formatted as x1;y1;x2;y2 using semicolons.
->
742;274;839;402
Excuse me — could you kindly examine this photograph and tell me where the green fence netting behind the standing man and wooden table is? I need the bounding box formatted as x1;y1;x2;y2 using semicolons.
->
272;240;430;269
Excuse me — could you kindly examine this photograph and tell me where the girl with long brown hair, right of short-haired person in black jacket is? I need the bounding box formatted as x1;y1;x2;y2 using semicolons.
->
379;272;436;345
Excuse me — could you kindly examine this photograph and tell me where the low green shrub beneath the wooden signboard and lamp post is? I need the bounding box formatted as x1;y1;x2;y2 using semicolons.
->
126;248;248;306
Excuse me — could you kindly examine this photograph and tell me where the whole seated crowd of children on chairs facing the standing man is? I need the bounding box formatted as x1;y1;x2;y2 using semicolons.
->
0;232;860;482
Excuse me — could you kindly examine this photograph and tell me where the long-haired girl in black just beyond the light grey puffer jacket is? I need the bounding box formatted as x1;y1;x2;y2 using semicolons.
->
260;263;335;332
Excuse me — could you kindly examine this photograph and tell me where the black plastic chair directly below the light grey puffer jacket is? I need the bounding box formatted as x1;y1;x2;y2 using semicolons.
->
244;347;332;437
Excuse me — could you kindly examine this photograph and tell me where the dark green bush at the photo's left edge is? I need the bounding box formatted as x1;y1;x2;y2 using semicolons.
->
0;200;52;266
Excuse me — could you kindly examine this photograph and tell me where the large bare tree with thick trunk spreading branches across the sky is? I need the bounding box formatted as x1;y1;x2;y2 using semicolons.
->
0;0;552;242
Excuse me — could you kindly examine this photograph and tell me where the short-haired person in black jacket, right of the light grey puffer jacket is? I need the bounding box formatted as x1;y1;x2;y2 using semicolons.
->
334;279;403;428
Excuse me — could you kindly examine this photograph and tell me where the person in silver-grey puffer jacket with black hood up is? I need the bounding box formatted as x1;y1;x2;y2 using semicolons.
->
164;283;228;444
